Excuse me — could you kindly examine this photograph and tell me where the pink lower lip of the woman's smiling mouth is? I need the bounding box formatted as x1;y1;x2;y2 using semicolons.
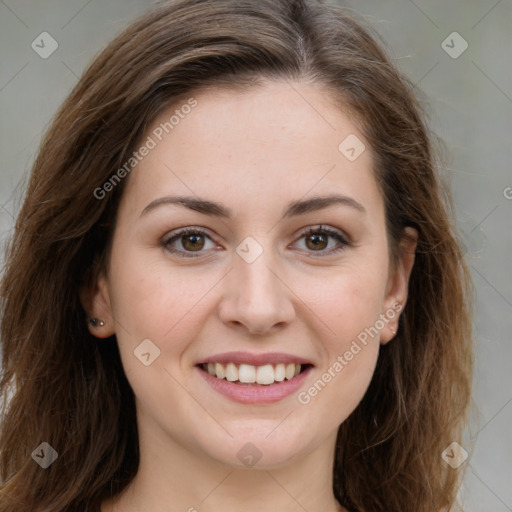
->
196;366;312;404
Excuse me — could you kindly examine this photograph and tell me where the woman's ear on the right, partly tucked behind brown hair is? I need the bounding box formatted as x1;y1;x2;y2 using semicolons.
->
380;227;418;345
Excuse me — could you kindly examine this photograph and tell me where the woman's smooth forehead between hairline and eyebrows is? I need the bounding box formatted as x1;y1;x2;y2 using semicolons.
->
120;82;382;222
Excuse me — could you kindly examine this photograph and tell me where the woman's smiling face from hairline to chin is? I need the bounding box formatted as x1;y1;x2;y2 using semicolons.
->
91;82;412;468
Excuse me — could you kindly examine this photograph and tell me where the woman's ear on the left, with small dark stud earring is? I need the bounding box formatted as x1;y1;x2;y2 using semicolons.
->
80;272;115;338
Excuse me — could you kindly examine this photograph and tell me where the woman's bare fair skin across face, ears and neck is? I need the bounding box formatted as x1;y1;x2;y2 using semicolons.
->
83;82;415;512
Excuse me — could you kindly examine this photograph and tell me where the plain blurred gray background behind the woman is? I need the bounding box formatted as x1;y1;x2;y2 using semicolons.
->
0;0;512;512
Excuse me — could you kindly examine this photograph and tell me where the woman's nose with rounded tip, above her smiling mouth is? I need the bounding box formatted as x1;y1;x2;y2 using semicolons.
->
218;250;295;335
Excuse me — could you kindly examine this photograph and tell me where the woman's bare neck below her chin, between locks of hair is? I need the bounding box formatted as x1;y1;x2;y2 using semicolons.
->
101;422;345;512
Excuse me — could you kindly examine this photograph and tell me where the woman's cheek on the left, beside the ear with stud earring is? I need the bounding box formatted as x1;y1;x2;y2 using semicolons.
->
106;251;212;416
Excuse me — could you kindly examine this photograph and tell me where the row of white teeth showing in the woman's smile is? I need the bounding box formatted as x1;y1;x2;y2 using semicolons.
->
203;363;300;385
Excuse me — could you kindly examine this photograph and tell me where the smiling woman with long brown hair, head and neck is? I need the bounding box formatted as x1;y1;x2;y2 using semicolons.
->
0;0;472;512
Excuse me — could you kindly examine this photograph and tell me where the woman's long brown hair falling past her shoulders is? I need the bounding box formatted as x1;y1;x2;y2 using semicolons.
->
0;0;473;512
